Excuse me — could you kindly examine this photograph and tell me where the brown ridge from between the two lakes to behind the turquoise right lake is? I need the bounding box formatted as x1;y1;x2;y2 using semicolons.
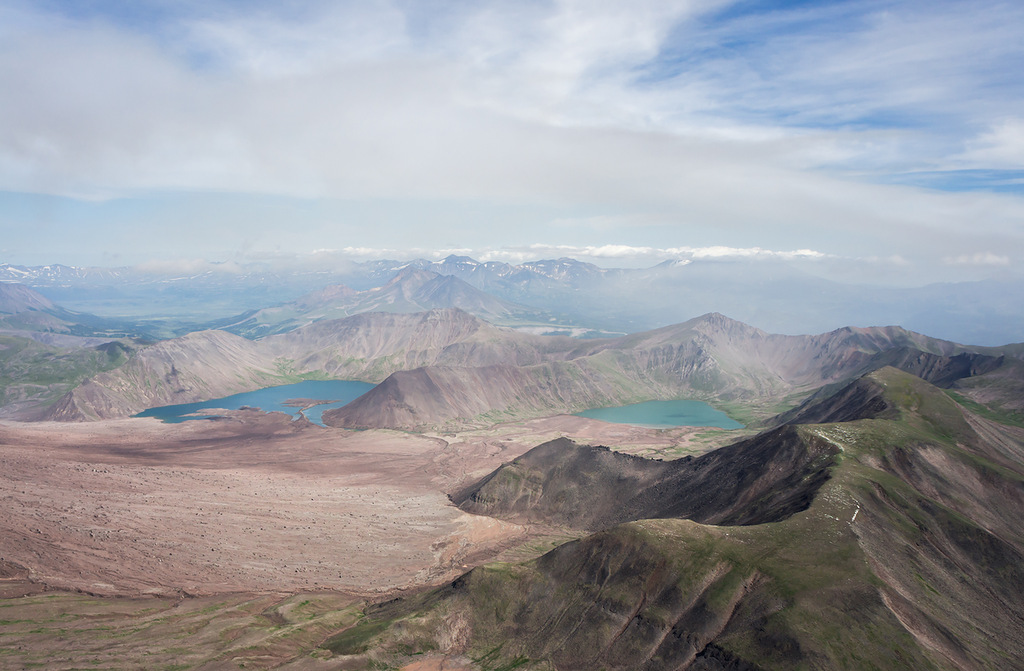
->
325;313;1011;428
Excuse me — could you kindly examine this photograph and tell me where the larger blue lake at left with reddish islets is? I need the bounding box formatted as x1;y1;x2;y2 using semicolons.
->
135;380;376;426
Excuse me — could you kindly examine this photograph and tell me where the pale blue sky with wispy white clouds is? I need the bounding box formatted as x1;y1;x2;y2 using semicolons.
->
0;0;1024;285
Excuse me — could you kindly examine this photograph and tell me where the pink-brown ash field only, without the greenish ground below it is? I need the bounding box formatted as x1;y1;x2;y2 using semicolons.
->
0;411;712;596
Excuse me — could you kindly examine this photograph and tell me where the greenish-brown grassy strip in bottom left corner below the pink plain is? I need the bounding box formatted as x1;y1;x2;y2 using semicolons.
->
0;592;358;671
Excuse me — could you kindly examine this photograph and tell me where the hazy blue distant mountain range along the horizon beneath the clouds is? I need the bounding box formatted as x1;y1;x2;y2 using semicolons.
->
0;256;1024;345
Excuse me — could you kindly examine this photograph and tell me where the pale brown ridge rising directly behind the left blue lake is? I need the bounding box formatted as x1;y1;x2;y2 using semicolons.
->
46;309;572;421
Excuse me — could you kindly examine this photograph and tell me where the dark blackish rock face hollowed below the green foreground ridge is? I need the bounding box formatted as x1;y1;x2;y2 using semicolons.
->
452;427;838;530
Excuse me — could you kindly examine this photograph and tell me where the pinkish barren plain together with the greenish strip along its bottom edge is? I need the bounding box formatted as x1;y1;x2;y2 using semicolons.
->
0;411;735;669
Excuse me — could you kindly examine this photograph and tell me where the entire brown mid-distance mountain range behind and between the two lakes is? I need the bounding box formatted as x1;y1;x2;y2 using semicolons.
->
12;308;1024;436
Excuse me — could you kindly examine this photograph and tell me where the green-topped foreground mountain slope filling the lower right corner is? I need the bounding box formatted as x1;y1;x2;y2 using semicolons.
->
326;368;1024;670
